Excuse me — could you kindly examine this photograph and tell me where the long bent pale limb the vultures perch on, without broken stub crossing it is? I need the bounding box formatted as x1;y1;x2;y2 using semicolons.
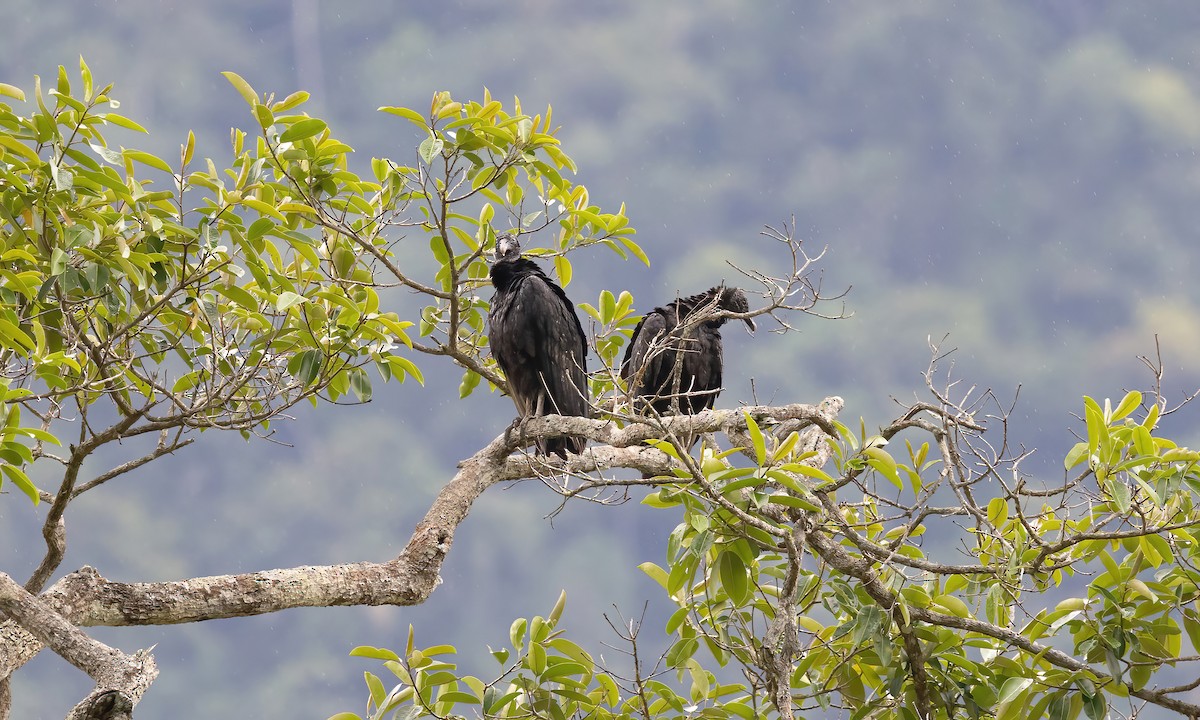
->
0;398;840;678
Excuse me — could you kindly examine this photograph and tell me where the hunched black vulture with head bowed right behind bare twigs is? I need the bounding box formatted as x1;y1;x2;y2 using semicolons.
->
620;286;755;415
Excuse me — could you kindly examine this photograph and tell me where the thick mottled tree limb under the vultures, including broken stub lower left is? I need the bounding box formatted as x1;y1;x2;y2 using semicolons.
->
0;398;841;720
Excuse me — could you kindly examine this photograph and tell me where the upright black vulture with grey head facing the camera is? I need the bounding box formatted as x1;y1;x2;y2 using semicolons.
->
487;235;592;460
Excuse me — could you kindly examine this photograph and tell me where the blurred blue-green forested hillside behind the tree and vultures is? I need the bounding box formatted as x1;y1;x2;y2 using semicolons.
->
0;0;1200;719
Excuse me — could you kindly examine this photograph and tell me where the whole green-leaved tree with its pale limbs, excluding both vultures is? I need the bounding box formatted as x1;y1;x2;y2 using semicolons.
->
7;61;1200;719
